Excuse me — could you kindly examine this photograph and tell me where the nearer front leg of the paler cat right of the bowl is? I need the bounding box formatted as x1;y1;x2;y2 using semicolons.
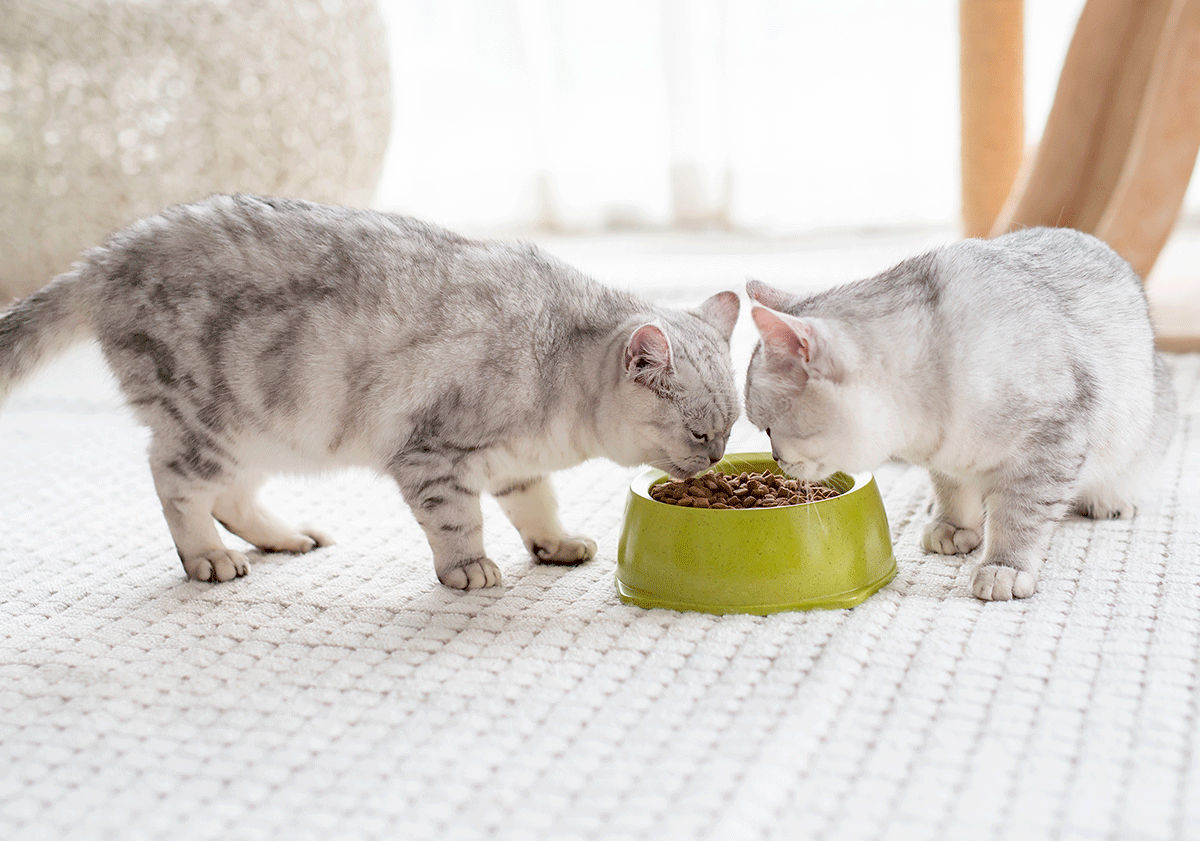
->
971;477;1070;601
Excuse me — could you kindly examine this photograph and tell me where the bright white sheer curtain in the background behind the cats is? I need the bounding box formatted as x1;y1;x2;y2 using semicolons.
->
378;0;1123;233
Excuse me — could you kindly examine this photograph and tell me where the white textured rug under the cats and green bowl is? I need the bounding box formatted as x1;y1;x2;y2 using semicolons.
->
0;340;1200;841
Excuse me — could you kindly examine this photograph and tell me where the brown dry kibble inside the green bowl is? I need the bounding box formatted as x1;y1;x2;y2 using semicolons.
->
650;470;841;509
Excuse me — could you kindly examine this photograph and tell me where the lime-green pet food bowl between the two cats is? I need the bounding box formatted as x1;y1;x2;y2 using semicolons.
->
617;452;896;614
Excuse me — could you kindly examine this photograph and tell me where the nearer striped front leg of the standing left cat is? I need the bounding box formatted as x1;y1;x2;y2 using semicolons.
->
392;462;500;590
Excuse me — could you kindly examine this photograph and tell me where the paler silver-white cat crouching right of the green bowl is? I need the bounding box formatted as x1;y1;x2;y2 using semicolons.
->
746;228;1176;600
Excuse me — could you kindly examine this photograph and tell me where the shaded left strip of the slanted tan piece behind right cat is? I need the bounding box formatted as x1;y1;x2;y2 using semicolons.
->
991;0;1171;236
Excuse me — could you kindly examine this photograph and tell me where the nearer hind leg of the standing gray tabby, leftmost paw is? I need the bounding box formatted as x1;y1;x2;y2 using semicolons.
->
150;445;250;581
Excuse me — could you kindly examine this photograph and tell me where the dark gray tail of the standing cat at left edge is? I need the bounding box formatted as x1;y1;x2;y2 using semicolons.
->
0;263;95;404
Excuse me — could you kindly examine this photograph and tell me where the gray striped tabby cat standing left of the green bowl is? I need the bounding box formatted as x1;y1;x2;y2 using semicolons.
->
0;196;738;588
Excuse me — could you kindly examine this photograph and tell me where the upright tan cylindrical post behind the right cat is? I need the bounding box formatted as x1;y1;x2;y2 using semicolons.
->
959;0;1025;236
